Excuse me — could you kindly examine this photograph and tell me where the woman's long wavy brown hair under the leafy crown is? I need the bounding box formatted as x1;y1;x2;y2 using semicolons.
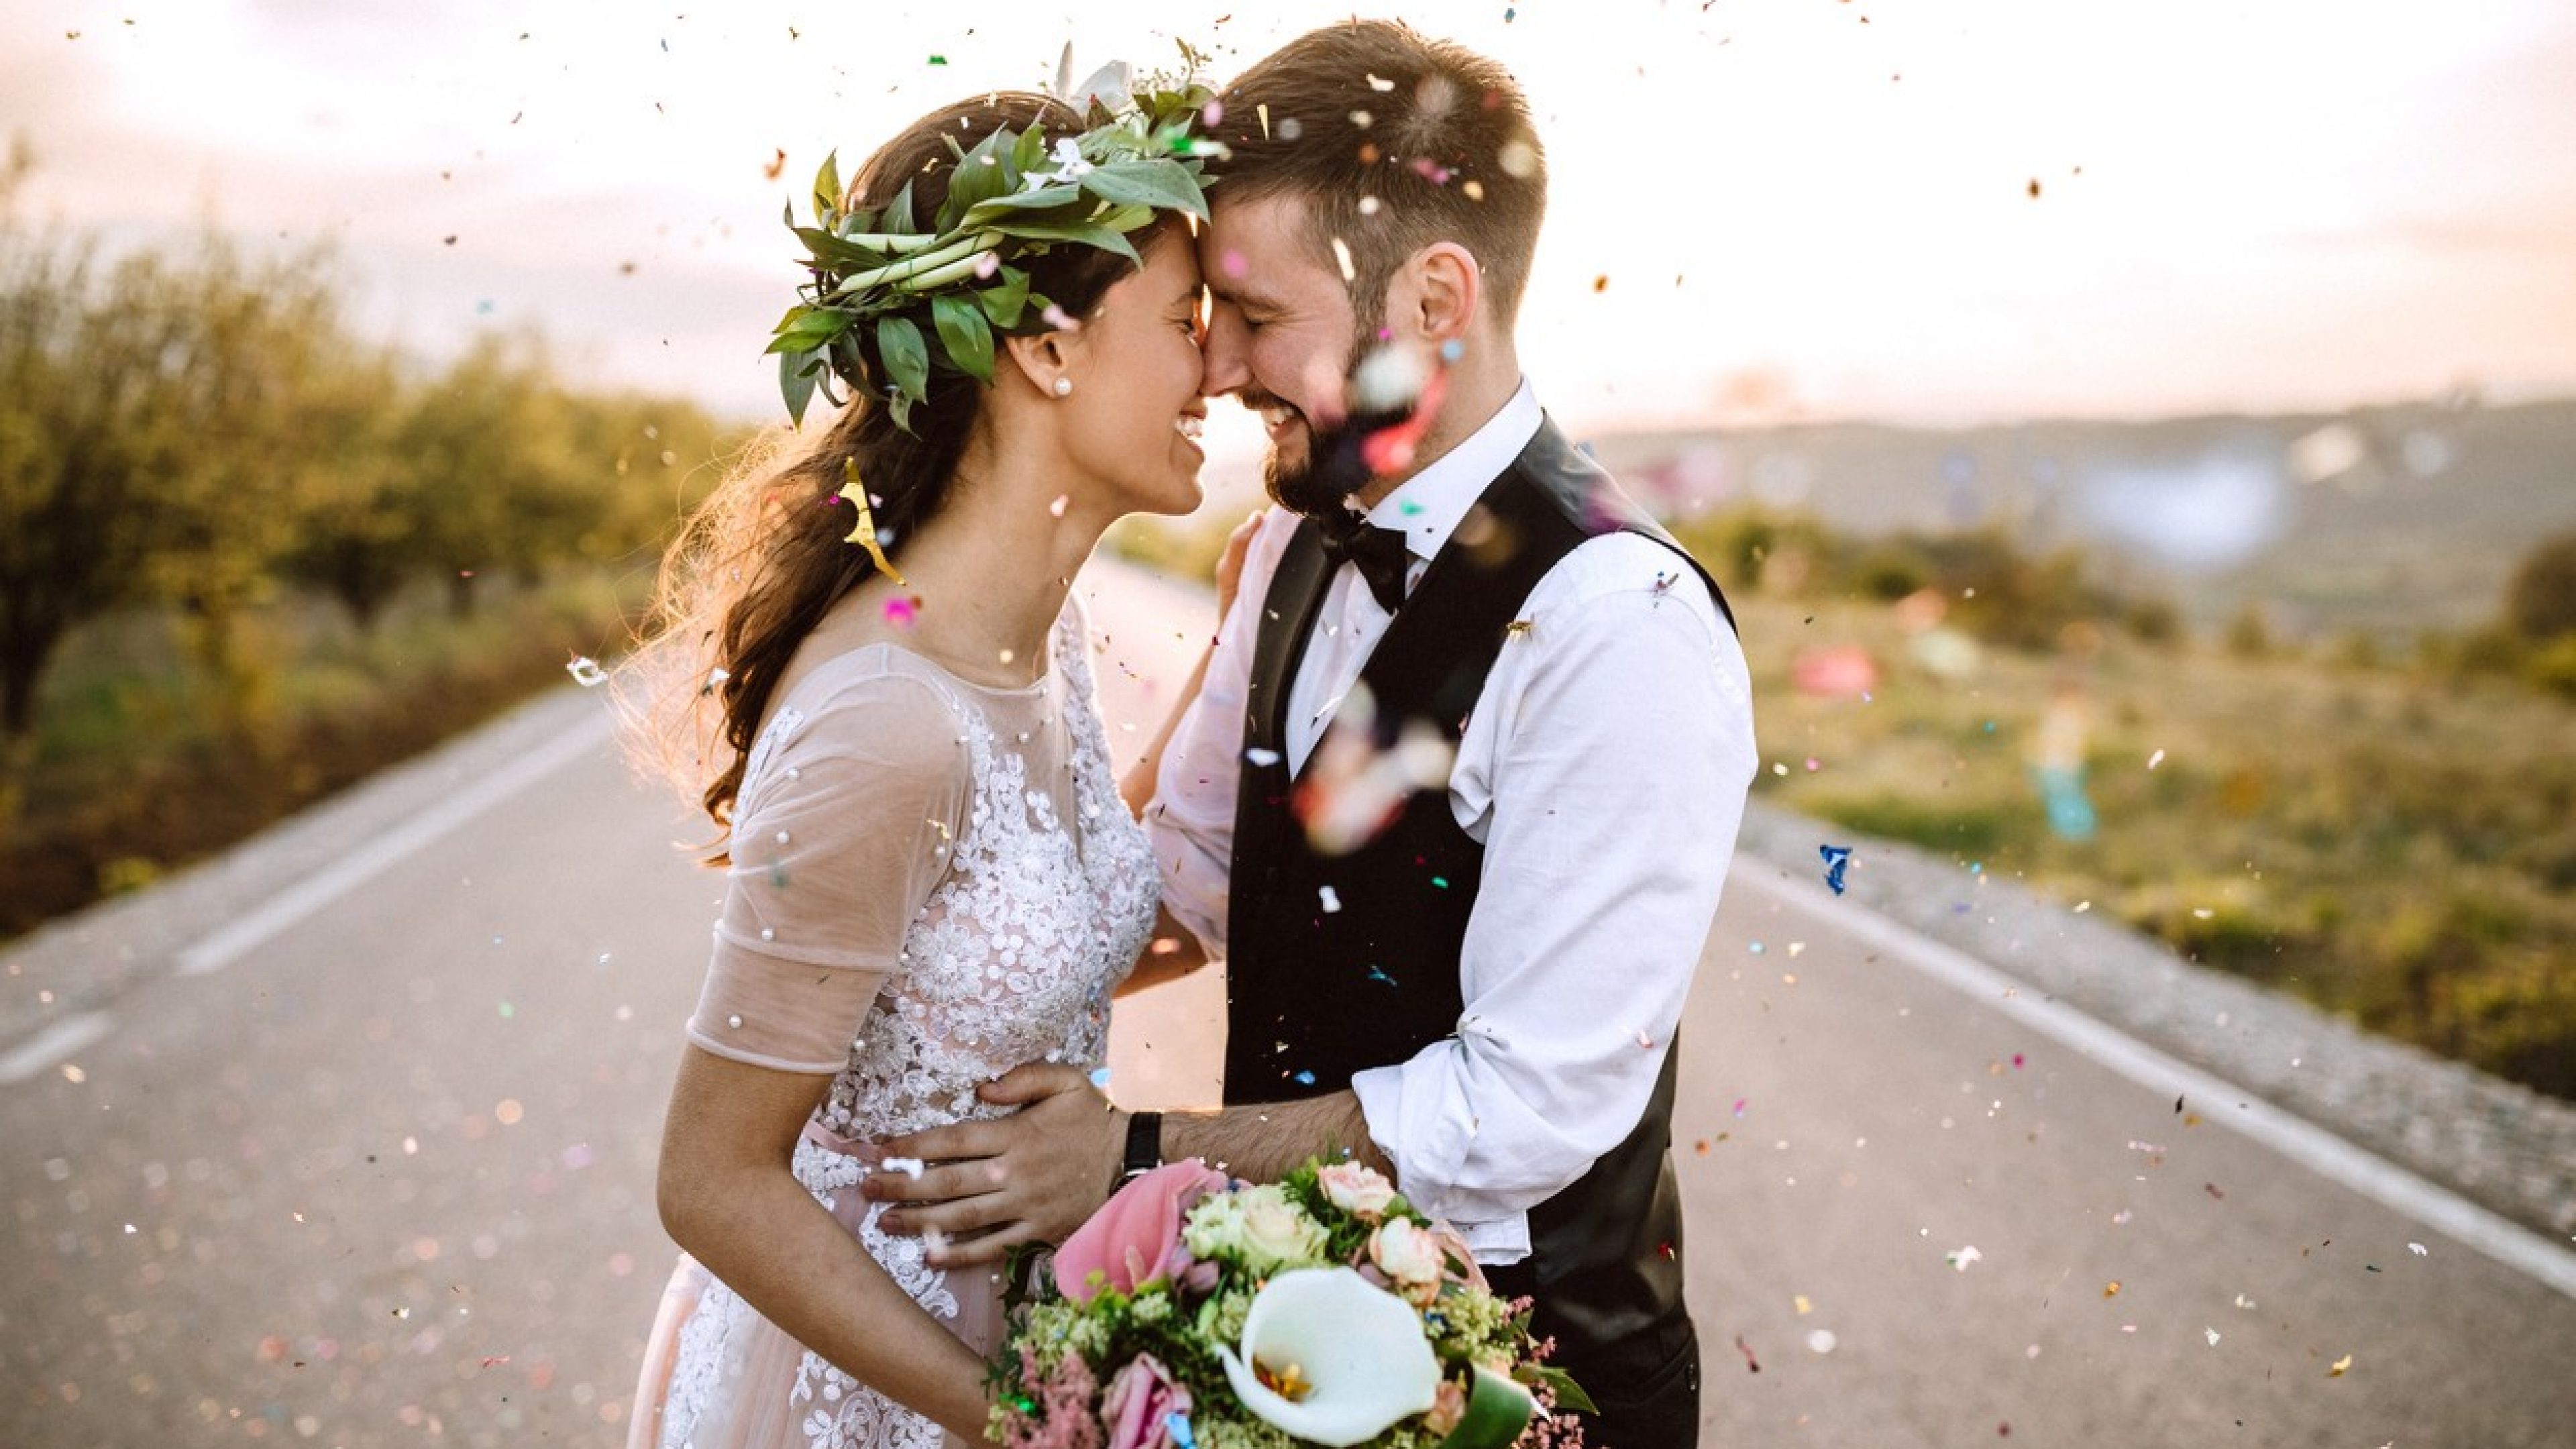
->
619;91;1169;825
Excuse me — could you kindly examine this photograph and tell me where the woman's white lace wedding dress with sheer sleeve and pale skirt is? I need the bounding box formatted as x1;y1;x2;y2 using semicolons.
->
629;601;1157;1449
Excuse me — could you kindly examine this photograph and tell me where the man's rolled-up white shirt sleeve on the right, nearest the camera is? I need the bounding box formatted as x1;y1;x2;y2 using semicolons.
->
1352;536;1754;1263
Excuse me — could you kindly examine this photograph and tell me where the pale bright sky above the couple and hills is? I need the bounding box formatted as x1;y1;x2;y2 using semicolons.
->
0;0;2576;428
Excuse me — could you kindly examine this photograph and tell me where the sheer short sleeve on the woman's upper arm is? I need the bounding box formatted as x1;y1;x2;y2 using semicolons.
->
688;673;974;1073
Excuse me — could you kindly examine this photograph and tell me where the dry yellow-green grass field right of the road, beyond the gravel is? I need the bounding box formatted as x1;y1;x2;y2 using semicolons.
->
1736;596;2576;1095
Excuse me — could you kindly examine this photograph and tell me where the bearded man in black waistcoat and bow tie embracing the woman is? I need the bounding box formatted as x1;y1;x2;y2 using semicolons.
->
865;21;1754;1449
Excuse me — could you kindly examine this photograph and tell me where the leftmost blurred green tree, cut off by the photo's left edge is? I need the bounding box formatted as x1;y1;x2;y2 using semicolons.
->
0;199;332;740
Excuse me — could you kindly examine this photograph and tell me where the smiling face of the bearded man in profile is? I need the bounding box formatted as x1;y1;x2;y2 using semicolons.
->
1198;196;1365;513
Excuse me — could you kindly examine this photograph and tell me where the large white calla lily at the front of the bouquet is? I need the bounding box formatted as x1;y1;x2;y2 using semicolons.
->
1216;1269;1440;1449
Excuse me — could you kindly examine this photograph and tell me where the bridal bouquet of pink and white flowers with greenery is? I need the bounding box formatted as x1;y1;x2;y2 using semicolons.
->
991;1161;1592;1449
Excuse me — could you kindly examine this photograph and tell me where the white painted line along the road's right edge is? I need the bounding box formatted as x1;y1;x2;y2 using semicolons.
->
1731;856;2576;1297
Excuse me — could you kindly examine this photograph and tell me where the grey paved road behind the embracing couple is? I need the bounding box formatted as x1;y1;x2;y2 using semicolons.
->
0;559;2576;1449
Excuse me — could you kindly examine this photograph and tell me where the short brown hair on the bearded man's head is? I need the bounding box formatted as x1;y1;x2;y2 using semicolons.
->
1208;21;1548;330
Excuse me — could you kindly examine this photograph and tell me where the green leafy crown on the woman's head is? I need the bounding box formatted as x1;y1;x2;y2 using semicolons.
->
767;64;1224;431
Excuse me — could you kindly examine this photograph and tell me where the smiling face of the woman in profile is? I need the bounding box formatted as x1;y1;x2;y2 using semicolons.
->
1061;229;1208;516
